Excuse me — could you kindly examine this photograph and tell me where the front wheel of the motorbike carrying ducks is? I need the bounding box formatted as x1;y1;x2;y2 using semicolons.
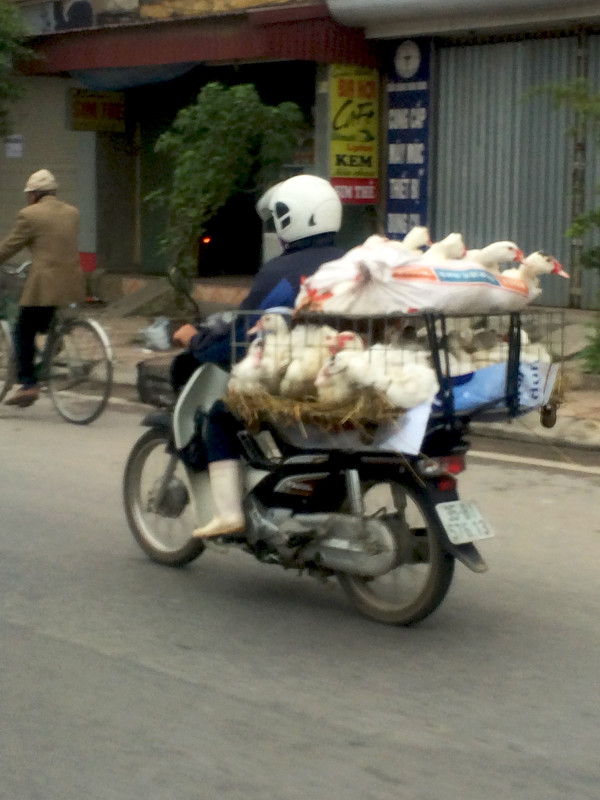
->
123;428;209;567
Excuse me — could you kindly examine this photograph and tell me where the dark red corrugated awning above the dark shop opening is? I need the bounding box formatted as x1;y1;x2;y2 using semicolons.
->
24;2;376;77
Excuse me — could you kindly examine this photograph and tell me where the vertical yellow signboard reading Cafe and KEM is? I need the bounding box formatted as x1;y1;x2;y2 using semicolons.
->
329;64;379;204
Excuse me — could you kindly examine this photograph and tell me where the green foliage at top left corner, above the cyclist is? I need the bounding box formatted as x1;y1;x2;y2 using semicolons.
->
0;0;33;135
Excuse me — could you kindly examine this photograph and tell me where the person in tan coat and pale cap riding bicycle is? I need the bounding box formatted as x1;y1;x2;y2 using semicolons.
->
0;169;85;408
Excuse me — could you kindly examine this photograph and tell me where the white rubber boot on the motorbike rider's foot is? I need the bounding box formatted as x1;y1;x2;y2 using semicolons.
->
192;459;246;539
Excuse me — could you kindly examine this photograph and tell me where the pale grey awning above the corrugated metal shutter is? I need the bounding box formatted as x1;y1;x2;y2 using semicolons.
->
326;0;600;39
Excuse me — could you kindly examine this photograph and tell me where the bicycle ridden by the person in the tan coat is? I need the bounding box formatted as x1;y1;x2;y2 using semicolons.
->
0;261;113;425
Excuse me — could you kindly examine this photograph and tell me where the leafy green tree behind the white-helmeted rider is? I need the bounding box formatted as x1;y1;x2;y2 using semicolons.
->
147;83;306;277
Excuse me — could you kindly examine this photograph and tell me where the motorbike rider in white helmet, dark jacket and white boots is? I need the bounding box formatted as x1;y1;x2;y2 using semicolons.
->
172;175;344;538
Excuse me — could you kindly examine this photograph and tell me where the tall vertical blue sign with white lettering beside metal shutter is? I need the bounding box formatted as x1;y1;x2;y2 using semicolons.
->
386;39;430;239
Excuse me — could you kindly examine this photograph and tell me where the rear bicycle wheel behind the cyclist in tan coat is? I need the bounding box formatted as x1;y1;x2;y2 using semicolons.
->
47;319;113;425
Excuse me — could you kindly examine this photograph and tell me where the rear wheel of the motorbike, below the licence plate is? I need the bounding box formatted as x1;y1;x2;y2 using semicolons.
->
338;482;454;625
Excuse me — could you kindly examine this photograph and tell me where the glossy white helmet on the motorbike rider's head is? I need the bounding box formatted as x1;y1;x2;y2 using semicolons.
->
256;175;342;243
